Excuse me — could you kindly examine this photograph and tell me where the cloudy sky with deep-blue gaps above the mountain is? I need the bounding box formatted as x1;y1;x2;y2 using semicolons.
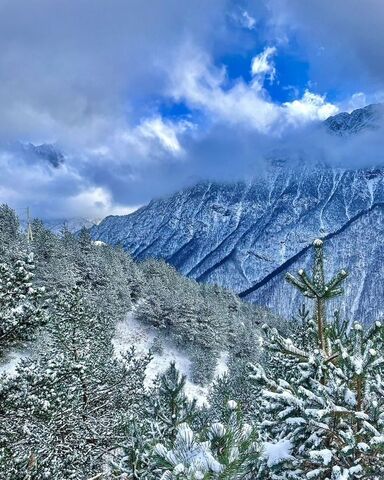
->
0;0;384;219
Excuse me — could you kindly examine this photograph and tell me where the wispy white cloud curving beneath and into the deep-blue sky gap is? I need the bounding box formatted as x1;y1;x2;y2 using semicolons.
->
165;47;339;135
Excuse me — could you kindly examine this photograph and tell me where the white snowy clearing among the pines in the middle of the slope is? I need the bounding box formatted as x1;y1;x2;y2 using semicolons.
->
113;310;227;404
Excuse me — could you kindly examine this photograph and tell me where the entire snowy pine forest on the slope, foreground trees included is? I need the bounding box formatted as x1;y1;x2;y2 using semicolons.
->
0;206;384;480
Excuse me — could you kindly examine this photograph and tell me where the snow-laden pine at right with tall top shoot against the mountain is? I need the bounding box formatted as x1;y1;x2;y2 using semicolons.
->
252;241;384;480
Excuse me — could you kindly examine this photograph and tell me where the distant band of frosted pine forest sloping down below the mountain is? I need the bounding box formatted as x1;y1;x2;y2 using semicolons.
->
0;205;278;372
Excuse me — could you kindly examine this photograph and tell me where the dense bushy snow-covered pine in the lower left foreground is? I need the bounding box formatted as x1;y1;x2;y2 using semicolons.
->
0;287;150;480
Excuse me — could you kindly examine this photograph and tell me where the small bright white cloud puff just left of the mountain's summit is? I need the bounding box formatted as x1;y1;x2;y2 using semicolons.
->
283;90;339;124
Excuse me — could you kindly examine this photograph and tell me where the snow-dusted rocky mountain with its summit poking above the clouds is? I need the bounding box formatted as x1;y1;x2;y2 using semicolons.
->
91;106;384;321
